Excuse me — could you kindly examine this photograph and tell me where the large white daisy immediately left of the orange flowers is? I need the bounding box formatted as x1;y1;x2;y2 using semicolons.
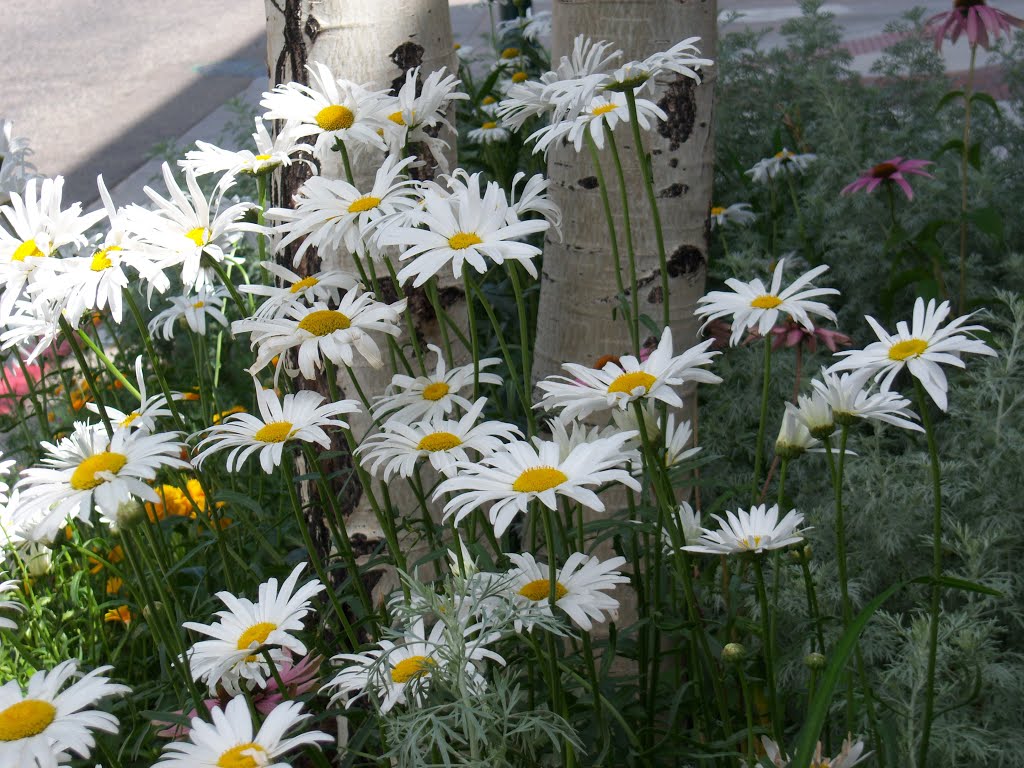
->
17;422;189;531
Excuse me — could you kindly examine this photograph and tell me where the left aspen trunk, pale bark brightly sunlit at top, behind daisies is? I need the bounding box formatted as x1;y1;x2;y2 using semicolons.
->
265;0;467;614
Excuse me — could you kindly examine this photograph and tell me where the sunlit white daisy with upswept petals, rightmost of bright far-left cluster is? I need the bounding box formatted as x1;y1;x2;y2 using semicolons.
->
125;163;255;289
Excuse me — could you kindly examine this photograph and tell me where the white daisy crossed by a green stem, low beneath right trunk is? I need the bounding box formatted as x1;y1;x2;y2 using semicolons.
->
506;552;630;632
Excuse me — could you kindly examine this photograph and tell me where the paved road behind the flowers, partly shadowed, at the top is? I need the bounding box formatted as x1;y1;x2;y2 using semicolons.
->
0;0;1024;207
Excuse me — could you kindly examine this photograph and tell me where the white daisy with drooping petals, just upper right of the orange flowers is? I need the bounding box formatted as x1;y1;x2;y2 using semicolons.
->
194;384;359;474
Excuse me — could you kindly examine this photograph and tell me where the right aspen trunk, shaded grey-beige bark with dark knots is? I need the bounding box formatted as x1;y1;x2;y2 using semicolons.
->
534;0;717;624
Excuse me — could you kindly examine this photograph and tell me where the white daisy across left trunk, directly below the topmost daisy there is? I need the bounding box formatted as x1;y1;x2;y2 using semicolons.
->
266;155;419;264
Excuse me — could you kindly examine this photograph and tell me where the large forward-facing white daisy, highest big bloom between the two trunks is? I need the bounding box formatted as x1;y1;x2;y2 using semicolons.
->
380;173;550;288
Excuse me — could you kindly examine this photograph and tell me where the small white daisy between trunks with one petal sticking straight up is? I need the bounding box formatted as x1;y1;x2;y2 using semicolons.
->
371;344;503;424
